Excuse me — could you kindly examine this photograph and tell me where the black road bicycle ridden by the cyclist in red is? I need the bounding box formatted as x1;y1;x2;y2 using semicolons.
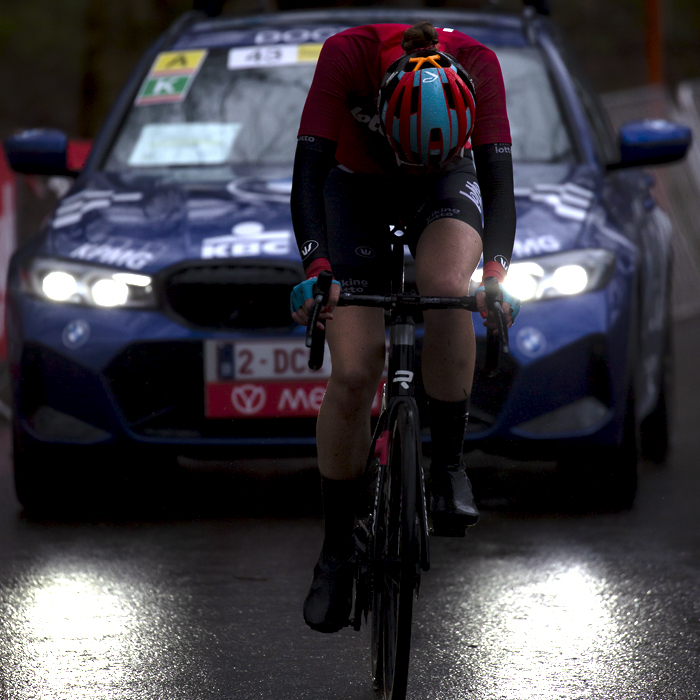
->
306;237;508;700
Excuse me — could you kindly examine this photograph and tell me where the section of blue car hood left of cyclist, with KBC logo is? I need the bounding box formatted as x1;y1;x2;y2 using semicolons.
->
41;169;301;274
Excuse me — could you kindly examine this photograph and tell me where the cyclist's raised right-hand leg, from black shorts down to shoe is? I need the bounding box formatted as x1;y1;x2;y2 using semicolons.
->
415;161;482;534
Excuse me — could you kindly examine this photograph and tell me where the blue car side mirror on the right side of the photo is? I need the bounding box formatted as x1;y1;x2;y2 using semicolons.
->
608;119;693;170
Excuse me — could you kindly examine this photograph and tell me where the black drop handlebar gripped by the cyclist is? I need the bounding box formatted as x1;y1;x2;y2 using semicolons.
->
306;270;509;376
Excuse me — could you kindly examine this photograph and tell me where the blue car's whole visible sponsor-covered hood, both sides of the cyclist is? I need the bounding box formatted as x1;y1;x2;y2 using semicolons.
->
40;165;604;274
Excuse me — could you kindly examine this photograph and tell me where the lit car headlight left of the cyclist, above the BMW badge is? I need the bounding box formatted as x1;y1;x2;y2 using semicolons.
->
22;258;156;308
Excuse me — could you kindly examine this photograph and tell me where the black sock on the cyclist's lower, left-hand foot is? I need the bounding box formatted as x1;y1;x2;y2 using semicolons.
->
321;476;364;557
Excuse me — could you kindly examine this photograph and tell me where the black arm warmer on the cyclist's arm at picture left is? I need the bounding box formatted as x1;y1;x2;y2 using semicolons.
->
291;136;337;269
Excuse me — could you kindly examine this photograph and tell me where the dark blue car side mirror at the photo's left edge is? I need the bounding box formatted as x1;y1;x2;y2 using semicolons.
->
5;129;76;175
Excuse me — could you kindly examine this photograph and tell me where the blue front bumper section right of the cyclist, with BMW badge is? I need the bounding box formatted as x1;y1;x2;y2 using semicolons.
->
465;290;633;459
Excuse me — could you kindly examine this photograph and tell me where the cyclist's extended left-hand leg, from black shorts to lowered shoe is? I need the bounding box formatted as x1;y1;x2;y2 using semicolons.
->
304;170;386;632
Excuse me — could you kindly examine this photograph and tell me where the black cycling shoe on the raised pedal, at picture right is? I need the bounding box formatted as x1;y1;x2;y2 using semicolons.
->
430;465;479;537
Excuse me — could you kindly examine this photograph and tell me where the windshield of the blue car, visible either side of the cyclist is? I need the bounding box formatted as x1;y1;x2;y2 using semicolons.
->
105;39;573;181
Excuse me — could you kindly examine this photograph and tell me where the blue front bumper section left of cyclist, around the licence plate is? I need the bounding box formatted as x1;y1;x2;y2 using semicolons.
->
8;297;316;458
